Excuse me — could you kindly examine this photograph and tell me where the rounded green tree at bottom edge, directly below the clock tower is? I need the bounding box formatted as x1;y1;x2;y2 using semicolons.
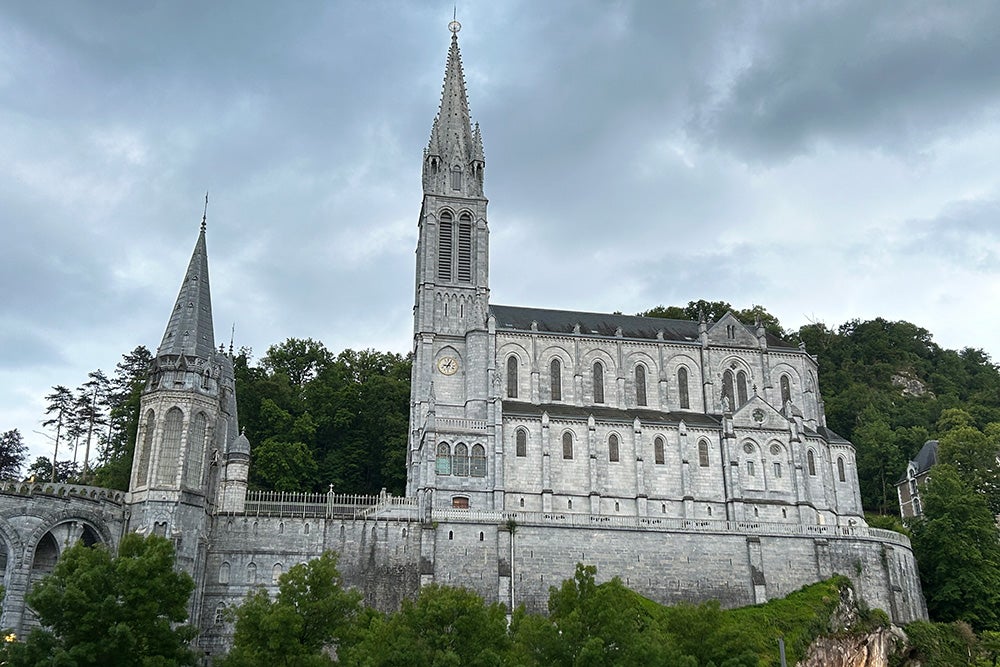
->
343;584;510;667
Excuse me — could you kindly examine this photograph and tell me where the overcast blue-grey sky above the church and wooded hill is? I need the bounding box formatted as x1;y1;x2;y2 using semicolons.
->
0;0;1000;470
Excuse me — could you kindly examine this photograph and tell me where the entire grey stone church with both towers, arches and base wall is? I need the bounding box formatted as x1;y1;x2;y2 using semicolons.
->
0;23;926;654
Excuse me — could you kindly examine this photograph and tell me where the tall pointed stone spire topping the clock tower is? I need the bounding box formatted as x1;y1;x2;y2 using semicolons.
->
423;21;486;197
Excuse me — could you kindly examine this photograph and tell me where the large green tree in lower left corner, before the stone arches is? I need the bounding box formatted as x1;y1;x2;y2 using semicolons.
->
11;533;196;667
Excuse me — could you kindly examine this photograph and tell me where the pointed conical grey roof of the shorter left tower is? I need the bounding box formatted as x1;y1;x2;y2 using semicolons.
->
156;222;215;359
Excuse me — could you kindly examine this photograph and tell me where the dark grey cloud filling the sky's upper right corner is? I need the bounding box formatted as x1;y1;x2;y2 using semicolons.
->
689;2;1000;162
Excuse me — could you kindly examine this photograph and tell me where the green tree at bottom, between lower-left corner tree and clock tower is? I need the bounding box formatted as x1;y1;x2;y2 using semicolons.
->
222;551;361;667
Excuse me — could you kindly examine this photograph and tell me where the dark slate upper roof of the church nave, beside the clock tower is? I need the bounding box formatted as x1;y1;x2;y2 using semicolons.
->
490;305;795;349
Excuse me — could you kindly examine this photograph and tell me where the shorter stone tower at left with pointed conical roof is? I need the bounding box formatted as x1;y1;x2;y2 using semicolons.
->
129;210;237;581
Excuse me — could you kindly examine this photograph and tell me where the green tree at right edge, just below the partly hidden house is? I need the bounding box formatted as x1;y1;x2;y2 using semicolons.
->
911;464;1000;631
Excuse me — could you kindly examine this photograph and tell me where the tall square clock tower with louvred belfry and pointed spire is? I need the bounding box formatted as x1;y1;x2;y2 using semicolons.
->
407;21;493;507
